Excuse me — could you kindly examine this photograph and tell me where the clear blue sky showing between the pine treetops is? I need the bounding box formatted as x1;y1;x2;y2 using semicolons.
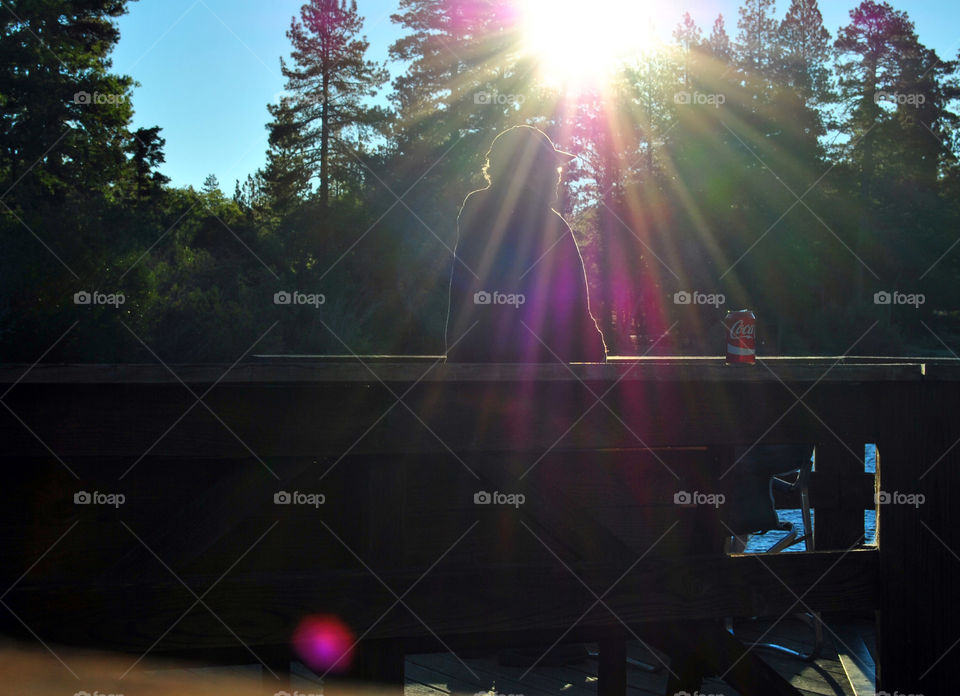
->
112;0;960;190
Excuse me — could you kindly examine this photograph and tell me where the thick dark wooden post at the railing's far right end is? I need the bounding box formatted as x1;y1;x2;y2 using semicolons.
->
877;380;960;694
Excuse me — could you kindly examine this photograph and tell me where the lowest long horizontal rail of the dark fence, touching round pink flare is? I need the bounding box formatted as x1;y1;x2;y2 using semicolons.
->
0;549;878;653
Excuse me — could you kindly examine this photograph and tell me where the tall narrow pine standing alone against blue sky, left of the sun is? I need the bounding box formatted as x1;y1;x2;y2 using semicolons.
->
278;0;387;207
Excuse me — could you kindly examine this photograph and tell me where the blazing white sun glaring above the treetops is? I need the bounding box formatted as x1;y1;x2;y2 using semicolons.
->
519;0;663;89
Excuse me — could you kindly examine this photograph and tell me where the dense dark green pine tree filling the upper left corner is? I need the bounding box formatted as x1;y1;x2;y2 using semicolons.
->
0;0;144;205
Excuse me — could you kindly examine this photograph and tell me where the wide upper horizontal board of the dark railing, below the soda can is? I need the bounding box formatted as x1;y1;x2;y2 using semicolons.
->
0;373;888;464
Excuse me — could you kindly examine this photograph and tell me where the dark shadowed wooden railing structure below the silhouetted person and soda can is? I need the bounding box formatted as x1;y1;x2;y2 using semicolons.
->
0;358;960;694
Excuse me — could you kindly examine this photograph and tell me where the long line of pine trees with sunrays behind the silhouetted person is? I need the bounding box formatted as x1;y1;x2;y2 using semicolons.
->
0;0;960;362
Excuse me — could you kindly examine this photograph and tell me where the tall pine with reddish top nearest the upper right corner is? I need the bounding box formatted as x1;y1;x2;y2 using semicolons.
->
835;0;957;302
